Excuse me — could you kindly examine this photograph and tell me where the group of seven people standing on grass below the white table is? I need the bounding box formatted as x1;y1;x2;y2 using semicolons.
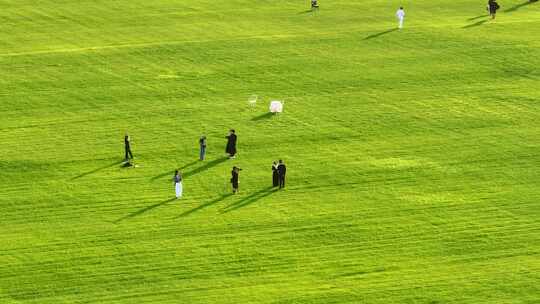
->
124;129;287;199
